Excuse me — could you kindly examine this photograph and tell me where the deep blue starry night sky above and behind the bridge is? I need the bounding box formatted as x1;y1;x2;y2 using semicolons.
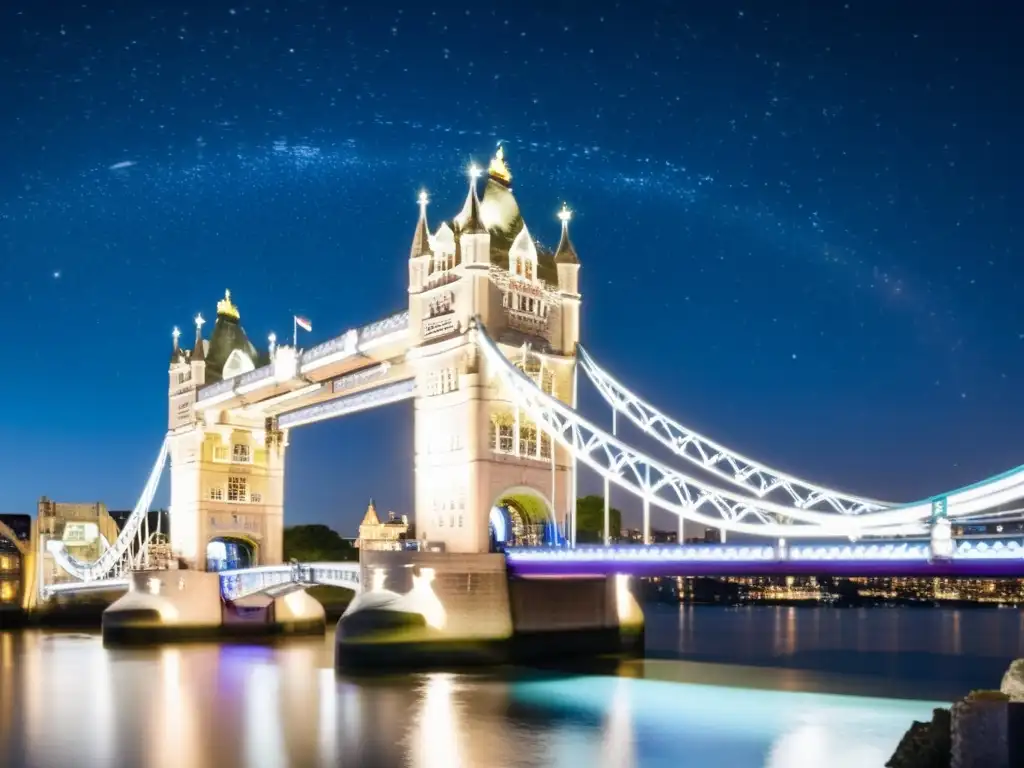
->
0;0;1024;534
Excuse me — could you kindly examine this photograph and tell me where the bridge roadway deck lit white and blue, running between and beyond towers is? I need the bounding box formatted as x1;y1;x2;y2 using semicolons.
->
47;539;1024;601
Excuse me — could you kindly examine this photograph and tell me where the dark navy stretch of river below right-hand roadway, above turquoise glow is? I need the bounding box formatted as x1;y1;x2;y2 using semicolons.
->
646;605;1024;699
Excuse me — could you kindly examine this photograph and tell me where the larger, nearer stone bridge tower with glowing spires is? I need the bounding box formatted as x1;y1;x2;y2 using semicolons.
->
409;147;581;553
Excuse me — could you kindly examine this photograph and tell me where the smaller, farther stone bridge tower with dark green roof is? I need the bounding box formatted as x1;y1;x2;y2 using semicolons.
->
168;292;287;570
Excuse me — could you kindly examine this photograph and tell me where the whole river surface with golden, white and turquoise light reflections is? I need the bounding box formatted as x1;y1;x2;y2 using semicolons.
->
0;606;1024;768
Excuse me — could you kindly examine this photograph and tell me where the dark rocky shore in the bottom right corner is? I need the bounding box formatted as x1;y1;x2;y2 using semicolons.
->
886;658;1024;768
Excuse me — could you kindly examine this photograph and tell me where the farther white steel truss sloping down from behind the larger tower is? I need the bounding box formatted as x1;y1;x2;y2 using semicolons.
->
577;345;896;515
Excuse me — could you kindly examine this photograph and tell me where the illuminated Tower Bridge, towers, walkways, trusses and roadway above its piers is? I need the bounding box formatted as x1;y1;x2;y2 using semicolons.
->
14;147;1024;659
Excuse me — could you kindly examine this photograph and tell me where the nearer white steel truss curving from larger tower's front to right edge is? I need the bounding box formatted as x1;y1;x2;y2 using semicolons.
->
474;321;1024;539
